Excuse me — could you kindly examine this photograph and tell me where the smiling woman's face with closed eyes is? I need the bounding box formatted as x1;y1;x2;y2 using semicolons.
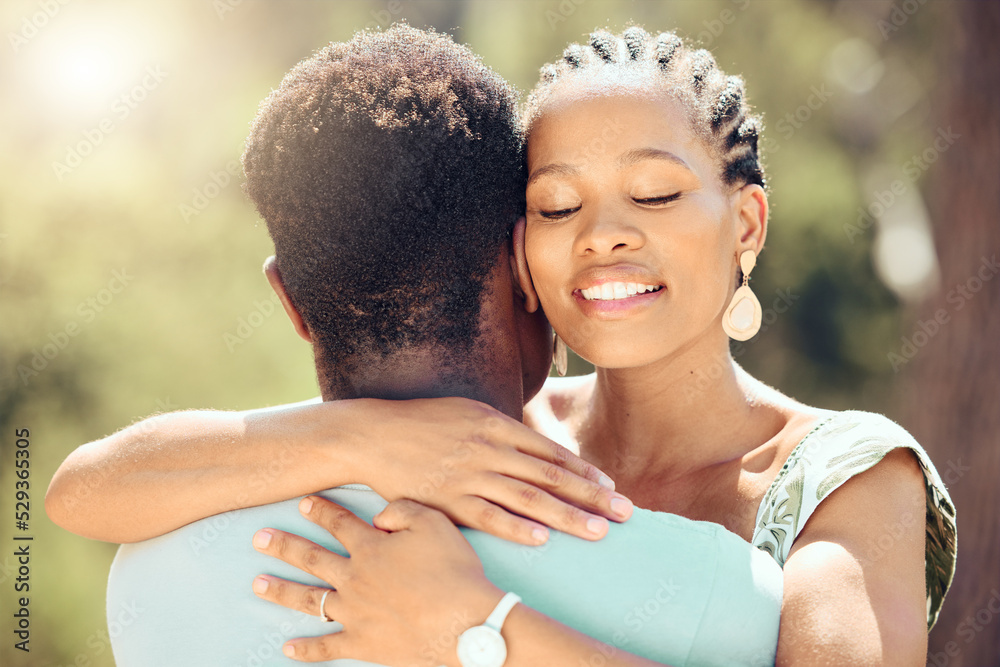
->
525;87;766;368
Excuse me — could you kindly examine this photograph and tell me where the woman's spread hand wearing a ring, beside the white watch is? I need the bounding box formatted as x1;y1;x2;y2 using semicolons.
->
253;496;503;665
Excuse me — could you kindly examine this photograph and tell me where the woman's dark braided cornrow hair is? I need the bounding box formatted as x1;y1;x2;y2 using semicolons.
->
523;26;766;186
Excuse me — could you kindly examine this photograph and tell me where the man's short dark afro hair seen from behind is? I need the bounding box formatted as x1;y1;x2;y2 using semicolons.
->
243;25;525;384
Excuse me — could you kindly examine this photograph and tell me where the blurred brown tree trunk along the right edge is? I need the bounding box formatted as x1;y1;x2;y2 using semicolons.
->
916;2;1000;666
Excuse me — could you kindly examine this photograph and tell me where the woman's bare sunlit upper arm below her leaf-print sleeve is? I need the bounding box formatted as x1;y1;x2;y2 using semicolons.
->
777;448;927;667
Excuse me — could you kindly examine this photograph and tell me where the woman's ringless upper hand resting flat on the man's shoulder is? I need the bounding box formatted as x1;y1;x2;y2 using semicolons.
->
340;398;632;545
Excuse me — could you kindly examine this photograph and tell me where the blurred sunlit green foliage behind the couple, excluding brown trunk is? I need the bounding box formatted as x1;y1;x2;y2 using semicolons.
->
0;0;948;667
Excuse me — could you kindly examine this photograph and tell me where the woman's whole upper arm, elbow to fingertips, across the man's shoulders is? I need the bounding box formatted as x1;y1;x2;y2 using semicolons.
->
45;398;631;544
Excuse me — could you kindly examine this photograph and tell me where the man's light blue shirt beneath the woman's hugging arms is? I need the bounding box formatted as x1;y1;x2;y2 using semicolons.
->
107;485;782;667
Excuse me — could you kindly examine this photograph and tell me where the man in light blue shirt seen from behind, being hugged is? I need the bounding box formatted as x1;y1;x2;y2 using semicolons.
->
108;27;781;667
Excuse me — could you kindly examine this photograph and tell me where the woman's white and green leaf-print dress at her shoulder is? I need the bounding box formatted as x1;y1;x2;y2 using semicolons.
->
751;411;956;630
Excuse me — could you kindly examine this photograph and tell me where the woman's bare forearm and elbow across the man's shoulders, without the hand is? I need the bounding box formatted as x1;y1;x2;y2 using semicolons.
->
45;399;342;543
